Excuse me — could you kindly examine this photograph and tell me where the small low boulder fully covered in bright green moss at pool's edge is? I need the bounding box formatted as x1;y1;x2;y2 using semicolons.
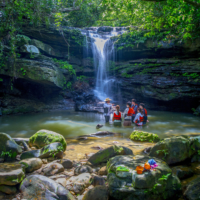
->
130;130;160;142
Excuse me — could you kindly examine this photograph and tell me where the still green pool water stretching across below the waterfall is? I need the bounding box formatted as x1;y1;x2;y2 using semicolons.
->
0;111;200;138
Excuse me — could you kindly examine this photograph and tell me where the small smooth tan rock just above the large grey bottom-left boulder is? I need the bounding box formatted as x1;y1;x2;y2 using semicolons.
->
20;158;43;173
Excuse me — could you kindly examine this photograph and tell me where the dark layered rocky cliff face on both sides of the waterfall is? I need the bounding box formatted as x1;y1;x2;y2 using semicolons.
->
0;27;200;114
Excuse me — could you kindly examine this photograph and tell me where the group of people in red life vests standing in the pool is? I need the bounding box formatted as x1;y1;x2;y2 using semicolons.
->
104;98;148;126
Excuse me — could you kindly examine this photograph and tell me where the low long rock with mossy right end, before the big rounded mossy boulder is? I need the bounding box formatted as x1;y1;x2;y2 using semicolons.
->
20;142;64;160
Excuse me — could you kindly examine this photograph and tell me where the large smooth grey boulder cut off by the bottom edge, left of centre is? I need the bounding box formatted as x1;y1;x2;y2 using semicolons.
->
20;175;75;200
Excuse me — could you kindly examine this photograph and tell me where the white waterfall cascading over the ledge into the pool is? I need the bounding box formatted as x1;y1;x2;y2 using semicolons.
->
81;28;123;101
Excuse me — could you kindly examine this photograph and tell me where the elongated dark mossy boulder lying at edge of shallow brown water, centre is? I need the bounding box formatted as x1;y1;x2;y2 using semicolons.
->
88;145;133;165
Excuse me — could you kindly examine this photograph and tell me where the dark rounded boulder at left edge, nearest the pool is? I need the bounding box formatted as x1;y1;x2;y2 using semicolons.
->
0;133;22;159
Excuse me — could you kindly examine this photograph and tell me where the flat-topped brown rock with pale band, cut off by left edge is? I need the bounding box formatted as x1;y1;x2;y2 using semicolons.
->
0;163;25;185
